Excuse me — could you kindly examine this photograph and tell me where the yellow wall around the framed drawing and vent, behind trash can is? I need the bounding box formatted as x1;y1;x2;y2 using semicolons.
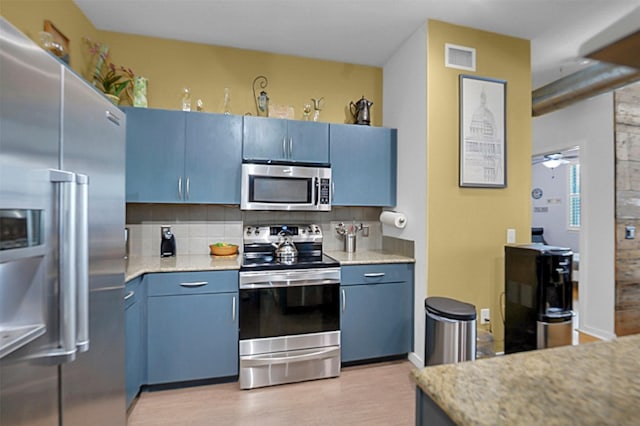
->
427;21;531;349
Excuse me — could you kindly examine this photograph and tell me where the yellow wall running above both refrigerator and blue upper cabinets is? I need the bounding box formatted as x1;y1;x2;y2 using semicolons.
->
0;0;382;125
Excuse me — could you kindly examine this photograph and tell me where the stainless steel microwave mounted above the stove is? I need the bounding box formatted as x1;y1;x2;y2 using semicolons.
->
240;162;331;211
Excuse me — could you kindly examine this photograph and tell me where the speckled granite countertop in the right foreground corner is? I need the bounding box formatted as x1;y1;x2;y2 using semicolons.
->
413;335;640;425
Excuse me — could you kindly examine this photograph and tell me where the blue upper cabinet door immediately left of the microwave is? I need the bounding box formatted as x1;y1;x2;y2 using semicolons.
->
184;113;242;204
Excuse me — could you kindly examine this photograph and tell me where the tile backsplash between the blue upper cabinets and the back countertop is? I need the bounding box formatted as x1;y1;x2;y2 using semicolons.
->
127;204;382;256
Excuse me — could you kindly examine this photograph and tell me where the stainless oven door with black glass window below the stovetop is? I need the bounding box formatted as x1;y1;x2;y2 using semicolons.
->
239;268;340;344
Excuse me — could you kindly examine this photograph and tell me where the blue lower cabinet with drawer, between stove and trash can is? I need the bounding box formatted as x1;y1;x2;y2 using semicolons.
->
341;265;413;362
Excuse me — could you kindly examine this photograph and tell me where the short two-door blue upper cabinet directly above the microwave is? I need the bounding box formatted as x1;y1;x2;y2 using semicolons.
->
242;117;329;163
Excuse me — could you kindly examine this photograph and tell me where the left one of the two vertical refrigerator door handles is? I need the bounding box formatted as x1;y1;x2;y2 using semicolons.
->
48;169;77;362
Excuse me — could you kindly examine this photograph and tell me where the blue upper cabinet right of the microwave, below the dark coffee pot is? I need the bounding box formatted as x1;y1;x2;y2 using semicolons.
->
329;124;398;206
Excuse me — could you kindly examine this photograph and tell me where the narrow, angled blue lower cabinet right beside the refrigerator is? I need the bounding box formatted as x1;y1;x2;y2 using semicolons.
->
125;277;145;407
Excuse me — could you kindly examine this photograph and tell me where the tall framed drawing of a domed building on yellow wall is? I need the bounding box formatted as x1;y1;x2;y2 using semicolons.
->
459;74;507;188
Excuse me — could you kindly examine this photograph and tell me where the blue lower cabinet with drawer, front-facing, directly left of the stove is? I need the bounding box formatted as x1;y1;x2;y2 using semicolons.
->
147;271;238;384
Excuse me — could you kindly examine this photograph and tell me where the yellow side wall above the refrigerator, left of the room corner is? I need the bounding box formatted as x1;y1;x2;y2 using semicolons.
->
0;0;98;74
